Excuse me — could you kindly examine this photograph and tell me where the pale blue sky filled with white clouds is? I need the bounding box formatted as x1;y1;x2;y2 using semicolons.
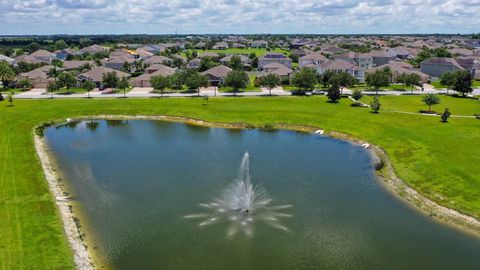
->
0;0;480;34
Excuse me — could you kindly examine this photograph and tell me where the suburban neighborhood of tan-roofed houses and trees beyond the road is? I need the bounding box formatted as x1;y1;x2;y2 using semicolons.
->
0;35;480;97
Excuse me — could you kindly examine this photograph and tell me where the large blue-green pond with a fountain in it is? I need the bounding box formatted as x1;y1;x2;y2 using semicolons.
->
45;120;480;270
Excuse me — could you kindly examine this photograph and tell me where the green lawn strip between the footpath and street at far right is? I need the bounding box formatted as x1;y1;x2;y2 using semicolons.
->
360;95;480;115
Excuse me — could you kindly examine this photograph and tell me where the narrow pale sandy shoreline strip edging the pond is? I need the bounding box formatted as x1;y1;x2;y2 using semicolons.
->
34;115;480;270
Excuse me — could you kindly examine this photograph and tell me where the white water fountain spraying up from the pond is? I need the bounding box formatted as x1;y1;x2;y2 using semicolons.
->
185;152;292;237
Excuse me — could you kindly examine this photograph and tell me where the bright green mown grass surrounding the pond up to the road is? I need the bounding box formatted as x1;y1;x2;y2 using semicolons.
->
0;96;480;269
